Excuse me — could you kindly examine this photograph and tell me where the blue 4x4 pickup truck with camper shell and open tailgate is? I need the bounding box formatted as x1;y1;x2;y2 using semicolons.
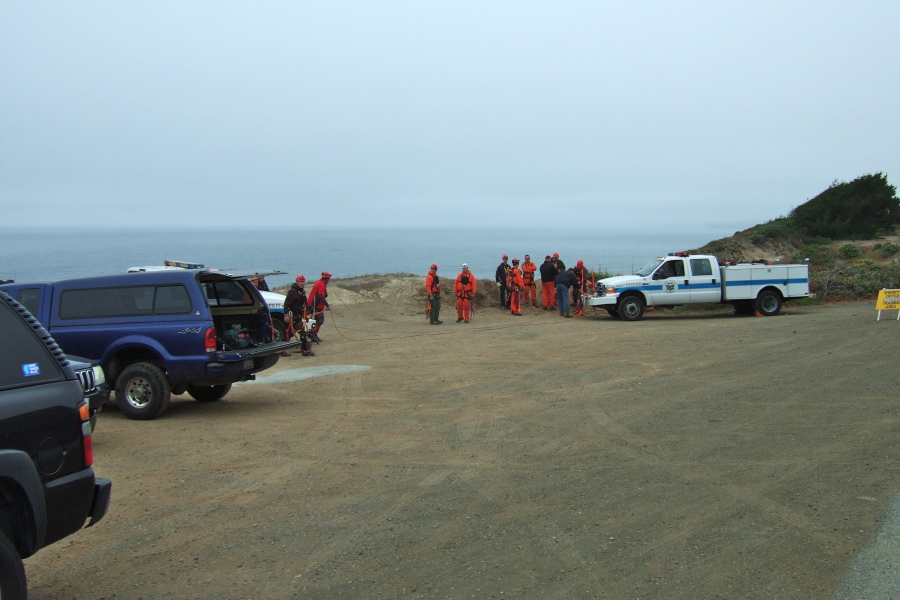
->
0;269;300;419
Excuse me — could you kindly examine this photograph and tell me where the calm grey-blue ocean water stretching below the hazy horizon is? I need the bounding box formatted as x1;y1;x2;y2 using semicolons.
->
0;226;734;286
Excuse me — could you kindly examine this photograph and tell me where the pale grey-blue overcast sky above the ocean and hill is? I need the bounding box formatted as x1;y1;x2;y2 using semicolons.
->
0;0;900;233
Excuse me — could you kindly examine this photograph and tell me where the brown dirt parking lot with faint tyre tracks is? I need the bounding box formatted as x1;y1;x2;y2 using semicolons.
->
26;288;900;600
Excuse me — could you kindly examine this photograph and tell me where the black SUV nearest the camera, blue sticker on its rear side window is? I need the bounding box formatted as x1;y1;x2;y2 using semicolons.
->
0;292;112;600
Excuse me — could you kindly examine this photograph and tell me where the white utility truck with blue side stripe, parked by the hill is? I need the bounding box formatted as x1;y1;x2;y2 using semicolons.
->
584;252;815;321
